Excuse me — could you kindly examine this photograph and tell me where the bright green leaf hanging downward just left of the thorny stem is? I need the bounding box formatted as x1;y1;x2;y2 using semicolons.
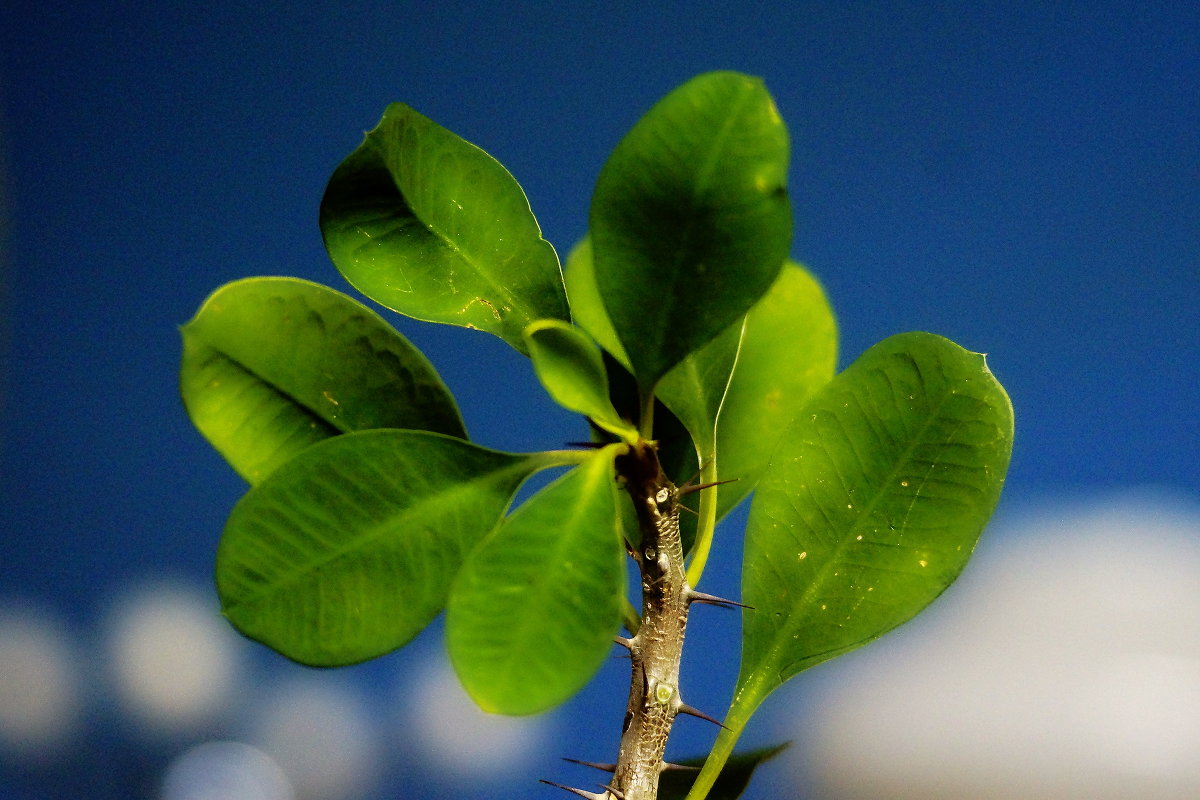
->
446;447;624;714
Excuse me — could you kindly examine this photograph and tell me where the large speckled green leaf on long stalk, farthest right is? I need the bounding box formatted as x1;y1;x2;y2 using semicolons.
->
697;333;1013;786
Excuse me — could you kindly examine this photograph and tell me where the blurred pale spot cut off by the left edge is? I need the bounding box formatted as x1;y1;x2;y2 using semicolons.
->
0;606;82;758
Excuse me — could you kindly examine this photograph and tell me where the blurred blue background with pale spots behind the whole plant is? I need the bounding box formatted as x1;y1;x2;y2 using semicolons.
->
0;0;1200;800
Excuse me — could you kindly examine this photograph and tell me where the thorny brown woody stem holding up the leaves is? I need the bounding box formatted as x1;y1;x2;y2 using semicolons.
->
613;441;691;800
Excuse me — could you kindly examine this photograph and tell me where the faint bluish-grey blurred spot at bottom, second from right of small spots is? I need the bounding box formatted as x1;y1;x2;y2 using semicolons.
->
251;672;383;800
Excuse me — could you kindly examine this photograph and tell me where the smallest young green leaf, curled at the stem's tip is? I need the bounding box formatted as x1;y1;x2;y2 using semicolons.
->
526;319;637;441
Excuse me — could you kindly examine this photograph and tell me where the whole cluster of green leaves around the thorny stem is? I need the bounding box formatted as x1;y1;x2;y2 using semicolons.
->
181;72;1013;798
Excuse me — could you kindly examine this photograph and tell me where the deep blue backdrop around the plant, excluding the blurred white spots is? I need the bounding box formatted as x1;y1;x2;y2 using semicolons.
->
0;0;1200;798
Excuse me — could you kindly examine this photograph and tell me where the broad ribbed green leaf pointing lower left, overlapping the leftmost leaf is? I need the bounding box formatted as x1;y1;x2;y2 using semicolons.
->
216;431;553;667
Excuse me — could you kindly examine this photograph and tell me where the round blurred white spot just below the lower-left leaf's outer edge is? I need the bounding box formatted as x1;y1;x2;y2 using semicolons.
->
106;582;244;734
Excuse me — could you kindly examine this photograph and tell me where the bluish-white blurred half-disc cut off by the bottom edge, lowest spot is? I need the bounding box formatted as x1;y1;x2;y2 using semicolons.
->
161;741;295;800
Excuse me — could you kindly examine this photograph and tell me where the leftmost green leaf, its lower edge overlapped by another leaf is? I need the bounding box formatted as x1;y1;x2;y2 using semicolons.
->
180;278;467;483
